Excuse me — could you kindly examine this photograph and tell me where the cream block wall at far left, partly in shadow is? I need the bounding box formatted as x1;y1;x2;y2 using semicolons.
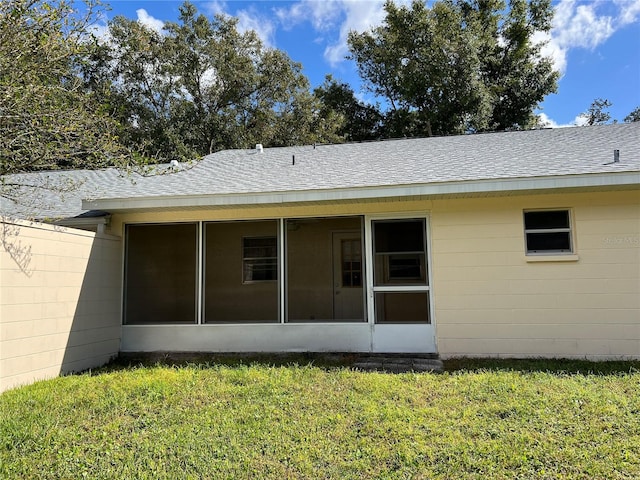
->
0;222;122;391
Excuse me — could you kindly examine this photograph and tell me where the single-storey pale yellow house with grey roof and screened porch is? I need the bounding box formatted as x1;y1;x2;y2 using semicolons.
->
3;123;640;390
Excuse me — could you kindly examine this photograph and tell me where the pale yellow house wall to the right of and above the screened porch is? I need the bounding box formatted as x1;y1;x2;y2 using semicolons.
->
112;190;640;359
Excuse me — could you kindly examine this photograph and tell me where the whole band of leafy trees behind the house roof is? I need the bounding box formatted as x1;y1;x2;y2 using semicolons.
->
0;0;640;191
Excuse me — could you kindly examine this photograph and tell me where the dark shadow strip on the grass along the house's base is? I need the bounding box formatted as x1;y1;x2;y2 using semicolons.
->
95;352;640;375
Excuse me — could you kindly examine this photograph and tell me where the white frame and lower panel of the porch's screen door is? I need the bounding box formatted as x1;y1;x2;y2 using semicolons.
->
364;212;437;353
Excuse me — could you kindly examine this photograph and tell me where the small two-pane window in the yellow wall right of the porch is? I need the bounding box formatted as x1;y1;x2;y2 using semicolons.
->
524;210;573;255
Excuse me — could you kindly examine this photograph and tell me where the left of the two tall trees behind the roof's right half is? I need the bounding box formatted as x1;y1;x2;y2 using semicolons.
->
349;1;482;135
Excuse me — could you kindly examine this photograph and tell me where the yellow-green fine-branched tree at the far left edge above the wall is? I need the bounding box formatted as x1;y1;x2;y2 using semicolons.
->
0;0;130;178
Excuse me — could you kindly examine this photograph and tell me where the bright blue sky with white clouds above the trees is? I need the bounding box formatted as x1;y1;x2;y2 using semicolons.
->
98;0;640;126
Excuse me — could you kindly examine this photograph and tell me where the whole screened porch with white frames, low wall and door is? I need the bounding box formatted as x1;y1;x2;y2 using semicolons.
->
122;213;436;353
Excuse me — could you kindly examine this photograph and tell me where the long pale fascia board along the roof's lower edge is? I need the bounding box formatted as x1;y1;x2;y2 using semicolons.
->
82;171;640;212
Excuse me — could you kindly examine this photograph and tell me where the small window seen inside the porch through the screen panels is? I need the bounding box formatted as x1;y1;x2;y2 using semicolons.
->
242;237;278;282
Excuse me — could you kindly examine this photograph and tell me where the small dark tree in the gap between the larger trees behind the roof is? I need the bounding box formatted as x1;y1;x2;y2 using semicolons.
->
313;75;383;142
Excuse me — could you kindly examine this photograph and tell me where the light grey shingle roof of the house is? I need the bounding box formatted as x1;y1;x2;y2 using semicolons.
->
2;123;640;221
